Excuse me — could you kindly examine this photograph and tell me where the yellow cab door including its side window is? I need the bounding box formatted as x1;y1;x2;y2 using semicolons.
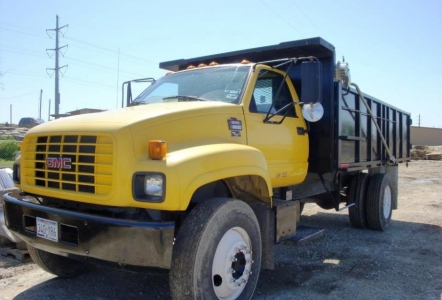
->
243;65;308;187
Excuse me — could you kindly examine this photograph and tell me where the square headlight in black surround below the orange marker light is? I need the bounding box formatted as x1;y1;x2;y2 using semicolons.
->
133;173;166;202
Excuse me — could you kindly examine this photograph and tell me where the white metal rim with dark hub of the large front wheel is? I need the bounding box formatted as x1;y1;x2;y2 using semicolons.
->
212;227;253;300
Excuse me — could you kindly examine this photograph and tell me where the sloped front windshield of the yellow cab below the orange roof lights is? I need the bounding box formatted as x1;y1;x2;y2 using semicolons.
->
131;66;250;105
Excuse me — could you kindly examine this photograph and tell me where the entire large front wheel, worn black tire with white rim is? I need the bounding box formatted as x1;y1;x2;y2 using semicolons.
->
170;198;261;299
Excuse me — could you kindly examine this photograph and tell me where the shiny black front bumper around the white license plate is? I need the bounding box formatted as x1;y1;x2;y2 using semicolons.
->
4;192;175;269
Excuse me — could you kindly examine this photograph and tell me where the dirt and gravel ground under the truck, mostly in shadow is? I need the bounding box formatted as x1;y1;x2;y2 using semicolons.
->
0;161;442;300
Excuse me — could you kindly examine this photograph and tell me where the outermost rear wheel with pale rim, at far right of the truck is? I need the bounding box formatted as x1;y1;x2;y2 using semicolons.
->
366;173;397;230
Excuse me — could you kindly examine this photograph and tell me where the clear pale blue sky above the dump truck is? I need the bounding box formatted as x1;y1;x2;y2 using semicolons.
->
0;0;442;128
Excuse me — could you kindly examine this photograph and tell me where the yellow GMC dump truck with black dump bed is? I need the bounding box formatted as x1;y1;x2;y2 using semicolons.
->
4;38;411;299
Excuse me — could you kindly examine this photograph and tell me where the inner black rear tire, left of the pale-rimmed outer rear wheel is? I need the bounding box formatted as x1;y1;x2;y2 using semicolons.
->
348;173;370;228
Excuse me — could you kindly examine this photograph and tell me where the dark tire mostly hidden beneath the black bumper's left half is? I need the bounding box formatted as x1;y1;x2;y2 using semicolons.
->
27;244;91;278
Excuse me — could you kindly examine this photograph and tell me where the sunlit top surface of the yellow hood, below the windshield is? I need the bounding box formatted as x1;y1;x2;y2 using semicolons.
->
28;101;239;134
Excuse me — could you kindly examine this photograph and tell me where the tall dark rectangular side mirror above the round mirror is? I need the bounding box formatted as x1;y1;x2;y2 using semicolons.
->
301;60;322;104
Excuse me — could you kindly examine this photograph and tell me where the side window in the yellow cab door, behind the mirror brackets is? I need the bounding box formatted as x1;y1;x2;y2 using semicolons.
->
250;70;296;117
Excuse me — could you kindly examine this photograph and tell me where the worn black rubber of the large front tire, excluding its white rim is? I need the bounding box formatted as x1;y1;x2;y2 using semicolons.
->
169;198;261;300
